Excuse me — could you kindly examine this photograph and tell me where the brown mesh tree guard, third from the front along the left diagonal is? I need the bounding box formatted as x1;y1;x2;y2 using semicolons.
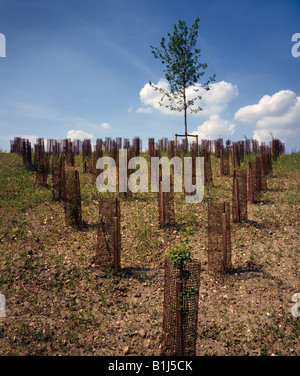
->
63;169;82;228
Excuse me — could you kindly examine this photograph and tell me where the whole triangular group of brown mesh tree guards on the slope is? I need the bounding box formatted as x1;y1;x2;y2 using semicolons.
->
11;137;284;356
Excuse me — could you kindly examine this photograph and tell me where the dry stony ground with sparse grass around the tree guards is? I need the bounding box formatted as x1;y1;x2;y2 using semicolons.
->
0;137;300;356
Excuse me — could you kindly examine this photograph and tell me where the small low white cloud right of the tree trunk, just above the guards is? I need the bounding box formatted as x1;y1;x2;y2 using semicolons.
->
191;114;236;140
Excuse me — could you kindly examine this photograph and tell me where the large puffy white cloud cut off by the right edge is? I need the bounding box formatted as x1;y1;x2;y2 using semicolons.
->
234;90;300;142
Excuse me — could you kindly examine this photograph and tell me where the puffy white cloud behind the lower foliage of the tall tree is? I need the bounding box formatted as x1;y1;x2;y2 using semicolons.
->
140;78;238;116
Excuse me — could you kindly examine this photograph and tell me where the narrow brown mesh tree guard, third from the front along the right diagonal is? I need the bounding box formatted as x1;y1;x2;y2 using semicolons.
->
232;169;248;223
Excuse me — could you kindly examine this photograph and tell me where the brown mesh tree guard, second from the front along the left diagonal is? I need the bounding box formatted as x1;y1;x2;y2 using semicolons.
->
96;195;121;272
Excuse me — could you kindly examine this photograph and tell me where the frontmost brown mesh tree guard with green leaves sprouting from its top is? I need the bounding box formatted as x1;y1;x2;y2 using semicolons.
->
161;257;201;356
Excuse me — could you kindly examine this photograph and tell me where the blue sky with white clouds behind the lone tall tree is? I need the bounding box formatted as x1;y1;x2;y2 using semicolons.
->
0;0;300;151
